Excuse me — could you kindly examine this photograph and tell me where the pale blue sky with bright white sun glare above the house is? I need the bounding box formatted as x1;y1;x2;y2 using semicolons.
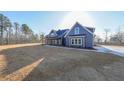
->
0;11;124;37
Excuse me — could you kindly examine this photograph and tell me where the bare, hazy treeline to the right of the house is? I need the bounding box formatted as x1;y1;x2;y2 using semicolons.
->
94;25;124;45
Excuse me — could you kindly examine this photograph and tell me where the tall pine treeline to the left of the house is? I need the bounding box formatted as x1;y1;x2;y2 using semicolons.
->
0;14;43;45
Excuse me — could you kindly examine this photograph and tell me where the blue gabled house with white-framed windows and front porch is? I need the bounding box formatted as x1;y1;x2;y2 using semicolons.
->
45;22;95;48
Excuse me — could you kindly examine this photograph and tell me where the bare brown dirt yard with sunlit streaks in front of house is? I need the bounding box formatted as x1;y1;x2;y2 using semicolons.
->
0;43;124;81
